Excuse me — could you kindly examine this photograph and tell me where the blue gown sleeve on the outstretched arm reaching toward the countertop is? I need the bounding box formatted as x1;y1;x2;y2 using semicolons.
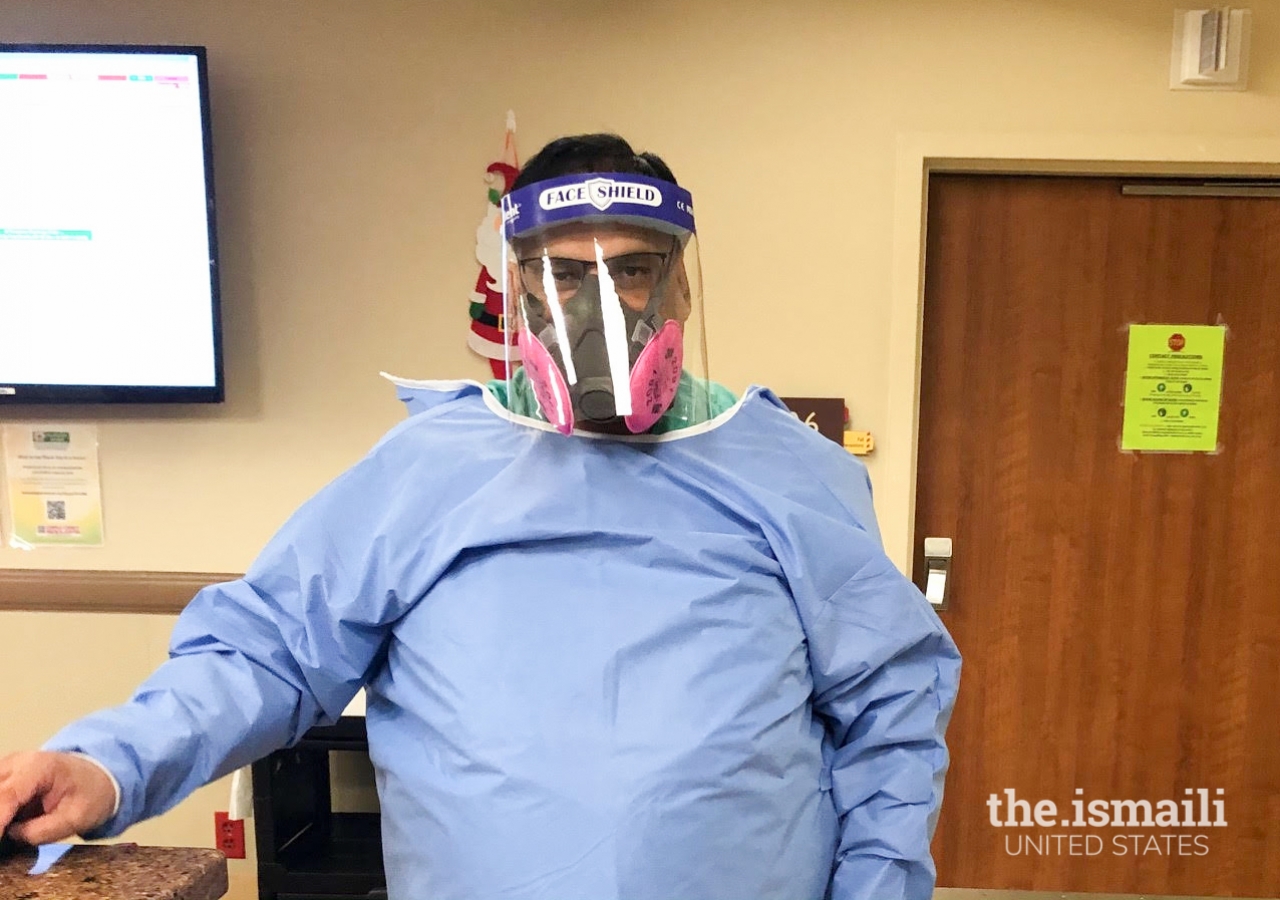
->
45;430;435;837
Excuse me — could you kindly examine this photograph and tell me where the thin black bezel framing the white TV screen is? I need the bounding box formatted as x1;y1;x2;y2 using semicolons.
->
0;42;227;407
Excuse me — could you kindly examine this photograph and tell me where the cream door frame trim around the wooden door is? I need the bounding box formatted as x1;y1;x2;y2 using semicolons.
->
876;133;1280;574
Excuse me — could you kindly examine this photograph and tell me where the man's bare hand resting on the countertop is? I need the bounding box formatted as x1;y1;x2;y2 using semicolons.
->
0;753;115;844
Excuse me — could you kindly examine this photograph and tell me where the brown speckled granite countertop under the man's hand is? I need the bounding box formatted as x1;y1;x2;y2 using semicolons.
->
0;844;227;900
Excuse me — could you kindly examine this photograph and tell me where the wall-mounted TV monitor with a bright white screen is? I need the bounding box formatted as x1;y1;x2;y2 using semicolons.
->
0;44;224;406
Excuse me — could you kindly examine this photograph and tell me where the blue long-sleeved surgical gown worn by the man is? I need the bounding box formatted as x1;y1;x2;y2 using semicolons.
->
47;383;959;900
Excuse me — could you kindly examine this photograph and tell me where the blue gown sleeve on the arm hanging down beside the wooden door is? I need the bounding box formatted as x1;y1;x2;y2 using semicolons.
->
759;399;960;900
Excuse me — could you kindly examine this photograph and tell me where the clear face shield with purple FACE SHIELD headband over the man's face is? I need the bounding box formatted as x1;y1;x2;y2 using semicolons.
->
503;174;710;434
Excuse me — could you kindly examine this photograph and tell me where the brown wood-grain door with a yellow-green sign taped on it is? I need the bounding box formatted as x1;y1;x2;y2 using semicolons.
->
916;175;1280;897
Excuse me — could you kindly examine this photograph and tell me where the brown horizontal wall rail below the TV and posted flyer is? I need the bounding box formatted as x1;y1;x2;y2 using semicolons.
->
0;568;239;616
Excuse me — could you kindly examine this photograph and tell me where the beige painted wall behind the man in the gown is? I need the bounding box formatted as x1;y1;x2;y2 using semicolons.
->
0;0;1280;885
